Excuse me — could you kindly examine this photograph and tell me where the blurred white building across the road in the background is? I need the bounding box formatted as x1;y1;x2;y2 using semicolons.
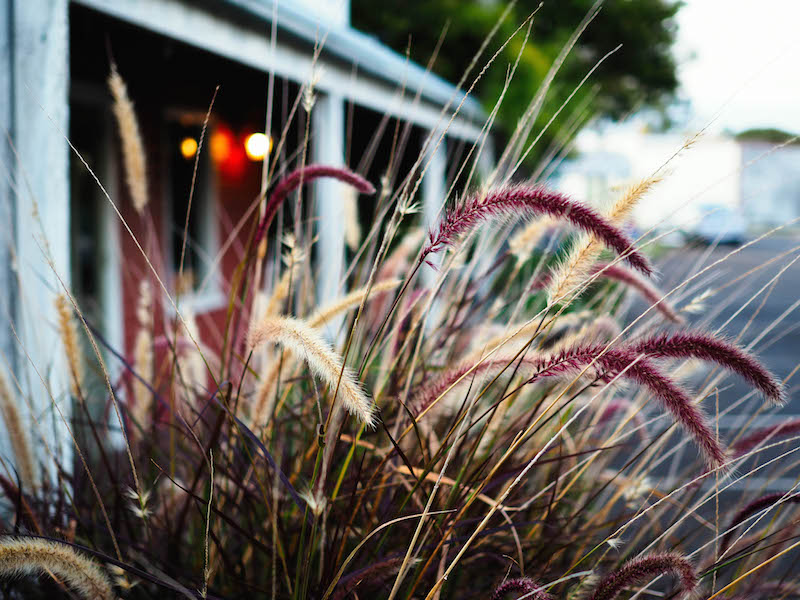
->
560;126;800;234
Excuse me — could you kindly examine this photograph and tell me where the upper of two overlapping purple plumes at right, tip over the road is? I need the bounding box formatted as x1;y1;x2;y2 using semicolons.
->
631;332;786;405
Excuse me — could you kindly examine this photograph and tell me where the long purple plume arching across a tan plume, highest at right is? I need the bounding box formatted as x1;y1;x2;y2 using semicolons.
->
420;185;652;275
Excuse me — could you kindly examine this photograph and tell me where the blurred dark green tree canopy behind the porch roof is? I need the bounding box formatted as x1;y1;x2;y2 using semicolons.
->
352;0;681;168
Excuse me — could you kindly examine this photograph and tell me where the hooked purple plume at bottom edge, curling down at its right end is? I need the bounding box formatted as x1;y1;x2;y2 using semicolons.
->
592;552;697;600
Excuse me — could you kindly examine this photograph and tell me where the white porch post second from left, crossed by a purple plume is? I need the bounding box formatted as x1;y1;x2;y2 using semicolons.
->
311;93;347;332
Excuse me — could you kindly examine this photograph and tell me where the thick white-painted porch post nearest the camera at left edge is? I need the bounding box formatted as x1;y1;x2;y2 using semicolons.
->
0;0;71;478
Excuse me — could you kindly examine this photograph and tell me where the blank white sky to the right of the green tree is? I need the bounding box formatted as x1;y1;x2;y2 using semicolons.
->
675;0;800;133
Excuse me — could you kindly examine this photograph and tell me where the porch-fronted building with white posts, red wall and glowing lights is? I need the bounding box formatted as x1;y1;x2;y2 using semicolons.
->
0;0;491;464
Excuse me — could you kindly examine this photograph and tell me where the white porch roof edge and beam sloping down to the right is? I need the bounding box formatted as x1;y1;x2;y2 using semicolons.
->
72;0;486;140
